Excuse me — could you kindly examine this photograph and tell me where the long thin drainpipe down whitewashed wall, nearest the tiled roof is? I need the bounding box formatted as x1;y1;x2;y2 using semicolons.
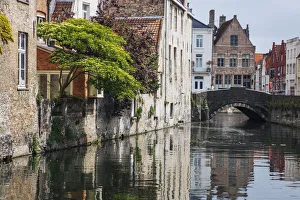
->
164;0;169;122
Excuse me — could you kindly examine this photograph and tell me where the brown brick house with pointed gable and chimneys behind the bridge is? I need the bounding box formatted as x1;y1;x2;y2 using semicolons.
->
209;12;255;89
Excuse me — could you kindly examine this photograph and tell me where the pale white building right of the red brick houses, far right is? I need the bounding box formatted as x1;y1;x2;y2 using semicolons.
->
285;37;300;95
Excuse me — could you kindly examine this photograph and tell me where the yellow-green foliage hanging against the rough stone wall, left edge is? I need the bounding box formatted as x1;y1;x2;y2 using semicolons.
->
0;14;14;54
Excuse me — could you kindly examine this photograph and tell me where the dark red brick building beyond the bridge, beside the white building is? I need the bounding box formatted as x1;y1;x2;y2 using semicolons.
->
266;40;286;95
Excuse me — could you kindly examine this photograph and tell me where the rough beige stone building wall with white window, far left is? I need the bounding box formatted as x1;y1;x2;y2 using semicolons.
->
0;0;38;159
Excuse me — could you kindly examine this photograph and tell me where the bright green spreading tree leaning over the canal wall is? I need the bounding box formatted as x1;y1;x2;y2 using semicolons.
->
38;19;142;100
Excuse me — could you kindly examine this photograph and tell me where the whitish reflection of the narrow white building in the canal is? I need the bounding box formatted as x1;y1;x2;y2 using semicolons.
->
190;149;211;197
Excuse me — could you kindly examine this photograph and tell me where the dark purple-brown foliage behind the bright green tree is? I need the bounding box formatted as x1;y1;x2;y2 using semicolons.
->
94;0;159;93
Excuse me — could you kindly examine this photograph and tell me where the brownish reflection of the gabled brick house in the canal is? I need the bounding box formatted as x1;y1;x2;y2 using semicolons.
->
211;151;253;199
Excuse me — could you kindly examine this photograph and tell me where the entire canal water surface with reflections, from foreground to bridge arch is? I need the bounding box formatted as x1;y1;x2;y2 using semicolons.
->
0;113;300;200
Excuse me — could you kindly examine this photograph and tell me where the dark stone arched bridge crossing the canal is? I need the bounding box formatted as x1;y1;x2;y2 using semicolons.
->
192;87;300;121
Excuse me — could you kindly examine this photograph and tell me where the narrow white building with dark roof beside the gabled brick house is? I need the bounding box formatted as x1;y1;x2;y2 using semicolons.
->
192;19;214;93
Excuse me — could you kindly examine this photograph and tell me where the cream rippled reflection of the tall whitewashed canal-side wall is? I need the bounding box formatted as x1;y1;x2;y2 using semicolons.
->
130;125;190;200
